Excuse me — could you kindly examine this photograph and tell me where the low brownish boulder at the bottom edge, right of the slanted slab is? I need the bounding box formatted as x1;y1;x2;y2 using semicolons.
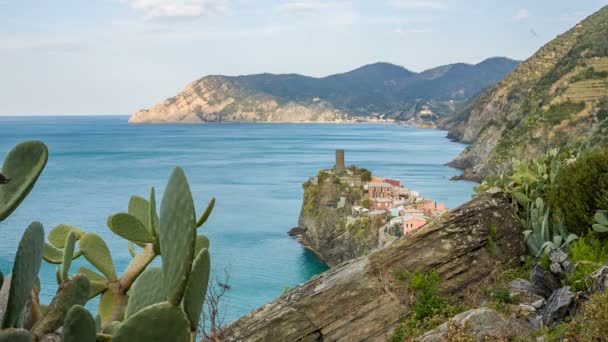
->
415;308;533;342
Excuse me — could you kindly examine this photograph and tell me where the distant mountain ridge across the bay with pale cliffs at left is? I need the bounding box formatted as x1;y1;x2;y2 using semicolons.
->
129;58;519;123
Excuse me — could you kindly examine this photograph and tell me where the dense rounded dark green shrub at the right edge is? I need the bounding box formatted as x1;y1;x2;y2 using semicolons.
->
549;149;608;235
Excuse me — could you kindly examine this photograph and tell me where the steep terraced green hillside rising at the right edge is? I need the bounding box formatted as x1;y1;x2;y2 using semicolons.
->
440;6;608;180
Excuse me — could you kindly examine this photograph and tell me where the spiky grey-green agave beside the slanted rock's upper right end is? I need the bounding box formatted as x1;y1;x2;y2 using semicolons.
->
524;198;578;257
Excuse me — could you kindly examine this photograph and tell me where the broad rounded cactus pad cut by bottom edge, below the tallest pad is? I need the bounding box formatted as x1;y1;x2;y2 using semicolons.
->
112;302;191;342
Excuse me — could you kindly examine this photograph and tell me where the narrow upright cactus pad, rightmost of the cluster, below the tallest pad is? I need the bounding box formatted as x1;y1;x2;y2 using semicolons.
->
184;248;211;332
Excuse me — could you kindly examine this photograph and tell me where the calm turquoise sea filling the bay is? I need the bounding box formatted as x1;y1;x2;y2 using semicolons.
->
0;116;472;320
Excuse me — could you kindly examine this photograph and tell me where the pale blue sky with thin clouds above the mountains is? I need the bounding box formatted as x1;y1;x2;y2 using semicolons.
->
0;0;608;115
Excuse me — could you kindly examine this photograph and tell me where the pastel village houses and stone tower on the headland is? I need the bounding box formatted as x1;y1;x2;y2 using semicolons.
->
326;149;448;248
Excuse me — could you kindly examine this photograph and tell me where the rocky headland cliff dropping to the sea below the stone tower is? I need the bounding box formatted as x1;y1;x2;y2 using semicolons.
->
290;171;386;266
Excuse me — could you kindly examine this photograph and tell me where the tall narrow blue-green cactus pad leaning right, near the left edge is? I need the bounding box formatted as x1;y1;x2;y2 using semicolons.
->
2;222;44;328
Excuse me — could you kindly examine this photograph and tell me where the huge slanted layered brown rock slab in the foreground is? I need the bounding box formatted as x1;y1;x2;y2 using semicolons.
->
227;193;526;341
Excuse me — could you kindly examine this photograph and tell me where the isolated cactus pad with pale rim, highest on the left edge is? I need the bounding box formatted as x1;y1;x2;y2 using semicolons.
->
0;141;49;221
